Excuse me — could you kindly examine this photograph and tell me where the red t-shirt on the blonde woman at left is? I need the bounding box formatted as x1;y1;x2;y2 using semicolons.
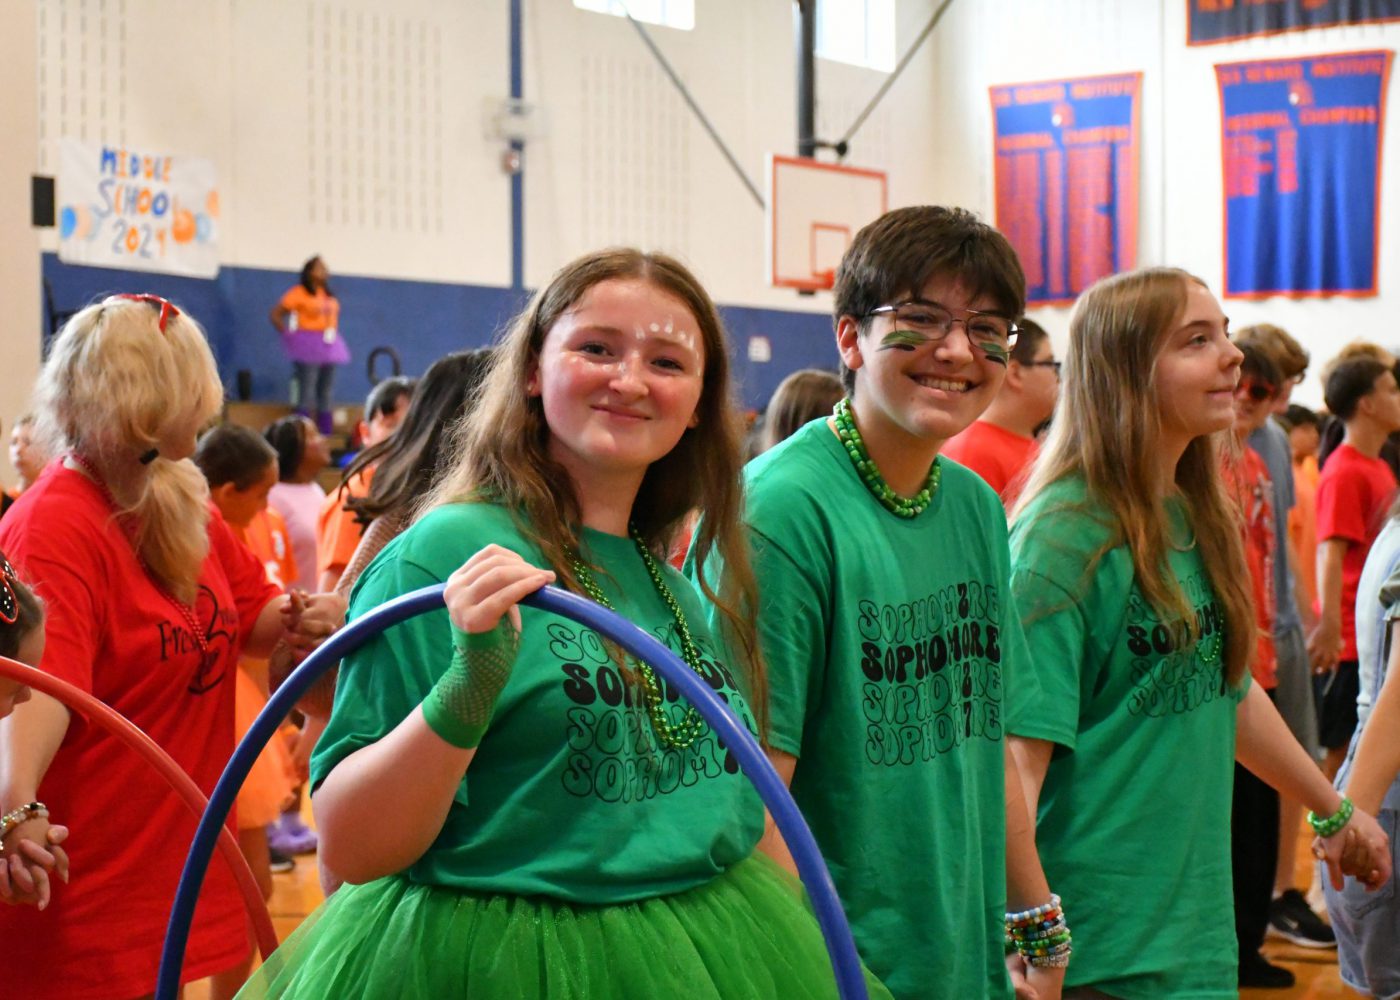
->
0;468;279;1000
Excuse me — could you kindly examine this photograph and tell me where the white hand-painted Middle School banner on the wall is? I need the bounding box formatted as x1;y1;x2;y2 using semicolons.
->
57;139;218;277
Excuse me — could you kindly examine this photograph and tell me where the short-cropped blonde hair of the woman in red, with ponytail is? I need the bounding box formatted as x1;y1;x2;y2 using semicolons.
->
35;297;224;604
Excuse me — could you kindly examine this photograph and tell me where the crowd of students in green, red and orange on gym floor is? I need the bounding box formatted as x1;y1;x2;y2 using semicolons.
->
0;207;1400;1000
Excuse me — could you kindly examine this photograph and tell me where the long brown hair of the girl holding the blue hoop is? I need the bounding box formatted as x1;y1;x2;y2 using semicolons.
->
423;248;767;708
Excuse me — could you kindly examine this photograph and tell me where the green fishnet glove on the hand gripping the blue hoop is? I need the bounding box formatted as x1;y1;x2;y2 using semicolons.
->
423;616;521;749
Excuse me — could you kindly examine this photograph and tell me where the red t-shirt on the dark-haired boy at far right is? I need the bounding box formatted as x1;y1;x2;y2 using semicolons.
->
1317;444;1396;660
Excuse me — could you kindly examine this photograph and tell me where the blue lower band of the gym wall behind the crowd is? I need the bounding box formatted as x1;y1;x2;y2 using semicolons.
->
43;254;837;409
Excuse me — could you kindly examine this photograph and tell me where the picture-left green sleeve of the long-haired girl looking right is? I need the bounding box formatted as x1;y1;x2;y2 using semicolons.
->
1008;569;1089;749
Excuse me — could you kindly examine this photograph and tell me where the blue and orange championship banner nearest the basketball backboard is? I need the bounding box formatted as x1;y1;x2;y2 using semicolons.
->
991;73;1142;305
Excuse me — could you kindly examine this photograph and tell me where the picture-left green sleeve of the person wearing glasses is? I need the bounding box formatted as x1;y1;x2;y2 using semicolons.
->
750;529;830;756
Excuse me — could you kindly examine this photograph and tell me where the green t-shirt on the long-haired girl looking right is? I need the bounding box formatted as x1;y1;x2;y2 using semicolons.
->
1011;479;1247;1000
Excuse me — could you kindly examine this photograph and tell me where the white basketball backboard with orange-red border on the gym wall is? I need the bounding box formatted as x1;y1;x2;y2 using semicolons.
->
766;154;889;291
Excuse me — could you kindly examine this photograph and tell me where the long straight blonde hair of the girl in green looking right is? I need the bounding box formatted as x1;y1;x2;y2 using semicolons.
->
1012;268;1257;685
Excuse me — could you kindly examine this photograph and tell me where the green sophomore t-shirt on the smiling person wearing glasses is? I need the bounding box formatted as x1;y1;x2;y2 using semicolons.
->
707;420;1037;1000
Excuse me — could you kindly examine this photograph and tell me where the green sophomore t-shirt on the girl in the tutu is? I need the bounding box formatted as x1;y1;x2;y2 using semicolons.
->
311;504;763;903
